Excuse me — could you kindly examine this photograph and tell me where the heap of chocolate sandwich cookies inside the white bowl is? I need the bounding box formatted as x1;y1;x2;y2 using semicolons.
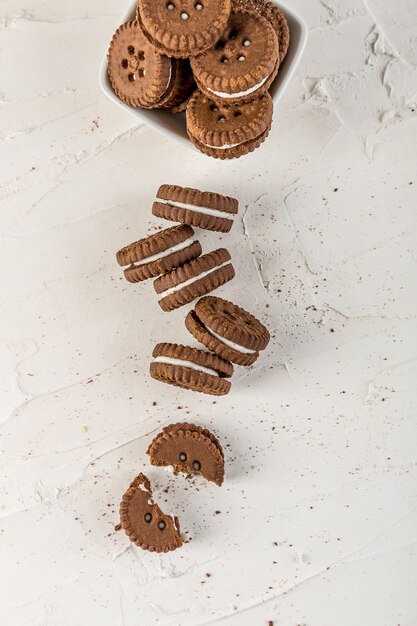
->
108;0;290;159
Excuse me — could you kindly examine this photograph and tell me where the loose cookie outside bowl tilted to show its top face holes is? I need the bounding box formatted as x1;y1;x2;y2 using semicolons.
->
185;296;270;366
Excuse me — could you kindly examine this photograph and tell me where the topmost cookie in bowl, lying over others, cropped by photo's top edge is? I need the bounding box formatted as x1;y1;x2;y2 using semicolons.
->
138;0;231;58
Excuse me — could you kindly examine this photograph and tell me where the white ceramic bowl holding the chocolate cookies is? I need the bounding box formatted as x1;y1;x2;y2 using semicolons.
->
99;0;307;150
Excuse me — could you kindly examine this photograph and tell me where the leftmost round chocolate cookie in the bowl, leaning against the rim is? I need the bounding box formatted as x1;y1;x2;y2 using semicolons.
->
108;20;173;107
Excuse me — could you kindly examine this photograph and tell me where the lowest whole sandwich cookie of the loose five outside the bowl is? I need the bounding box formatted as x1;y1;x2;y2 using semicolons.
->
149;343;233;396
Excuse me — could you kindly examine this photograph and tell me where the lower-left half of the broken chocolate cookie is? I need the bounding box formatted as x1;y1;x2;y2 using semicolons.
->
120;474;183;552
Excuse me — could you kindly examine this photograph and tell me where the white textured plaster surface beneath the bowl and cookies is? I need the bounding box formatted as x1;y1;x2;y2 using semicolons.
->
0;0;417;626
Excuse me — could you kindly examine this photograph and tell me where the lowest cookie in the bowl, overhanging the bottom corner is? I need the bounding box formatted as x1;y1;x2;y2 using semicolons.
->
187;92;273;159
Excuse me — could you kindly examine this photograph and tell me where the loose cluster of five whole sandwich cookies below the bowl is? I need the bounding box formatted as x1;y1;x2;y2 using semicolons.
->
116;185;269;396
